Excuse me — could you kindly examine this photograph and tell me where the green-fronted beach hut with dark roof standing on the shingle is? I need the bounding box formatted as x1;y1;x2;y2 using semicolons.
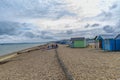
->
70;37;87;48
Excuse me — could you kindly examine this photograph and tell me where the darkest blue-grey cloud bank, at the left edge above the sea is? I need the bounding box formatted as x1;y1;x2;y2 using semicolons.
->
0;21;37;35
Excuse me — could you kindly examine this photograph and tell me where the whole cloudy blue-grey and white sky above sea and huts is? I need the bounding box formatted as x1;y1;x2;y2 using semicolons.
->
0;0;120;43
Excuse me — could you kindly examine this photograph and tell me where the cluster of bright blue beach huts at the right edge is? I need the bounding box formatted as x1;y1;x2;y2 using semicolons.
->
95;34;120;51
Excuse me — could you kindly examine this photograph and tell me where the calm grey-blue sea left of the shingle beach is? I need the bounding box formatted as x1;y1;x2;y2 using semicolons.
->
0;43;46;56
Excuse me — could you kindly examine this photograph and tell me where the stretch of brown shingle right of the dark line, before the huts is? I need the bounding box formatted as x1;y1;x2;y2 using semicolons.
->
57;45;120;80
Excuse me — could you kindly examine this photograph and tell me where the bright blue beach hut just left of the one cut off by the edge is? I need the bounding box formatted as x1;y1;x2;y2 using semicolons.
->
95;34;115;51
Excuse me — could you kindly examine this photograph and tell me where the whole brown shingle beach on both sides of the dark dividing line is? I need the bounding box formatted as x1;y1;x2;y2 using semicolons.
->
0;45;120;80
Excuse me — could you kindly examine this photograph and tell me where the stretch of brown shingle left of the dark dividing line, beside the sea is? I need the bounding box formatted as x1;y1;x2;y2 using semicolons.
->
0;47;66;80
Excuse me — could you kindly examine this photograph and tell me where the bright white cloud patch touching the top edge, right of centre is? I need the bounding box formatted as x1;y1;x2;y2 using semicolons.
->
65;0;101;17
